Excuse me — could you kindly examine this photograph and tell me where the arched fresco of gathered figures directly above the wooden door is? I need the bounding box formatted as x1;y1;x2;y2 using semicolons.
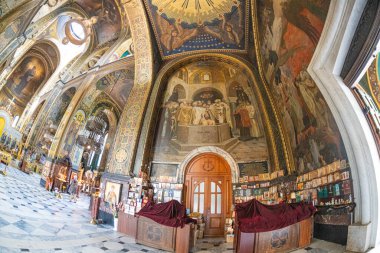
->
153;61;268;164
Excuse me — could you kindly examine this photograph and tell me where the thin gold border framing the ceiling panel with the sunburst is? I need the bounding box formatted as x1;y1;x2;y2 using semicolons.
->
143;0;250;60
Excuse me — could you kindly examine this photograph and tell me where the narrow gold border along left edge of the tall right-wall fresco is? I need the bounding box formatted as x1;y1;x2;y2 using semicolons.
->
251;0;295;172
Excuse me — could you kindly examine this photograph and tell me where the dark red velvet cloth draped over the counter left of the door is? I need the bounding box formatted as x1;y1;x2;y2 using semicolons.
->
137;200;195;227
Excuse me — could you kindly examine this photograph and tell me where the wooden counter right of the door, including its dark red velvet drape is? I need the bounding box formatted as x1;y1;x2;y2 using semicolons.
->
234;200;316;253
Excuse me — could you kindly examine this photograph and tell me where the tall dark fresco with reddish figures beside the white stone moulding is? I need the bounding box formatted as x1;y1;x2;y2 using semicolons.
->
256;0;346;173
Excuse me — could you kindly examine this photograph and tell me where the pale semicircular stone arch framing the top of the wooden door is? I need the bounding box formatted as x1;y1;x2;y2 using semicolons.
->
177;146;240;183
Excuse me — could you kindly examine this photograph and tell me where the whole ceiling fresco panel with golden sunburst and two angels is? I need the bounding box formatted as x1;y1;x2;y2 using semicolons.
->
144;0;249;58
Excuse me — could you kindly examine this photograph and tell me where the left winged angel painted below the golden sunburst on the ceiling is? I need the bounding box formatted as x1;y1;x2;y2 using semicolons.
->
156;14;198;51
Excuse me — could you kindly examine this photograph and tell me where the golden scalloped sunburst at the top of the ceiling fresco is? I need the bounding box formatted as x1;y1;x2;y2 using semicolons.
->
152;0;239;24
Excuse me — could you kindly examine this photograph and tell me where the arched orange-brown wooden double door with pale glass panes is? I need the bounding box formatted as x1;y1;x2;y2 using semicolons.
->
185;153;232;236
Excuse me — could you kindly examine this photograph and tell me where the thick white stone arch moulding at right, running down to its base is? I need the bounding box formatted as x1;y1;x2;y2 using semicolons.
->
308;0;380;249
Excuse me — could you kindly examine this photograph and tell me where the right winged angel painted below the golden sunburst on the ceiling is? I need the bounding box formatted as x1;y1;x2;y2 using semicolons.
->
204;4;244;45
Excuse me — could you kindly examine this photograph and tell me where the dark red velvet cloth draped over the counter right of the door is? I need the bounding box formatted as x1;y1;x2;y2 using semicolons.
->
235;199;316;233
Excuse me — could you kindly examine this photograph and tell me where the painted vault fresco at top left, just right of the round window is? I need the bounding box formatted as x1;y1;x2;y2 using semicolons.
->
77;0;121;44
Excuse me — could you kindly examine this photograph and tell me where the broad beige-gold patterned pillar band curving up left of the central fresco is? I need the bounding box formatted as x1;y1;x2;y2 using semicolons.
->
108;0;153;175
